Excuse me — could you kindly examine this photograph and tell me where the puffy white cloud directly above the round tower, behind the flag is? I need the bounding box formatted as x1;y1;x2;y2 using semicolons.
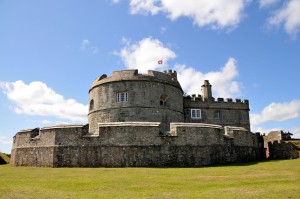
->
116;37;176;73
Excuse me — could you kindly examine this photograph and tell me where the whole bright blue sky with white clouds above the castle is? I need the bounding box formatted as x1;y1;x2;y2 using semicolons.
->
0;0;300;153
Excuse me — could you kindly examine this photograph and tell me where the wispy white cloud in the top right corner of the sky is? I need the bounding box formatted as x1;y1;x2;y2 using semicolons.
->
268;0;300;37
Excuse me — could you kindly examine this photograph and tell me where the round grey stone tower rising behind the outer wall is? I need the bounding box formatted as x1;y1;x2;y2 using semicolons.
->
88;70;184;133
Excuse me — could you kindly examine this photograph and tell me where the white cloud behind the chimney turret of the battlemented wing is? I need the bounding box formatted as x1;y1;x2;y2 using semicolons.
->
175;58;240;97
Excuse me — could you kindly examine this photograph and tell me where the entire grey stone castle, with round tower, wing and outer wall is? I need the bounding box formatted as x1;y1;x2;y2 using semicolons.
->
11;70;263;167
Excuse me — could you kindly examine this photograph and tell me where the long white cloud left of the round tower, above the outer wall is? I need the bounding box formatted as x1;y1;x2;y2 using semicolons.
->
0;80;88;123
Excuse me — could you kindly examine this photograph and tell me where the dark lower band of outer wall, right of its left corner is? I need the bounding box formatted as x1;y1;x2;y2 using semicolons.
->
54;142;259;167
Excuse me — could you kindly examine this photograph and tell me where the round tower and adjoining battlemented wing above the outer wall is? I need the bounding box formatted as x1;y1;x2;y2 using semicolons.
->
88;70;250;133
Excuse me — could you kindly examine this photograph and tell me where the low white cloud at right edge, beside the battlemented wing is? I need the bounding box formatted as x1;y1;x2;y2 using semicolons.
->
250;100;300;125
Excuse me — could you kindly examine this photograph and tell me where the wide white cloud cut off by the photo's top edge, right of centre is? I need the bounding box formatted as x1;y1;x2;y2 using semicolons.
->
130;0;251;29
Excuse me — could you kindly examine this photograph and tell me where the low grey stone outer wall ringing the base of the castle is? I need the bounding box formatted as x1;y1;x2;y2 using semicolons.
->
12;122;259;167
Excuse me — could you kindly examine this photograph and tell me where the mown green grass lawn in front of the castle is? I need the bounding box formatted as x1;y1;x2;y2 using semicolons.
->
0;159;300;198
